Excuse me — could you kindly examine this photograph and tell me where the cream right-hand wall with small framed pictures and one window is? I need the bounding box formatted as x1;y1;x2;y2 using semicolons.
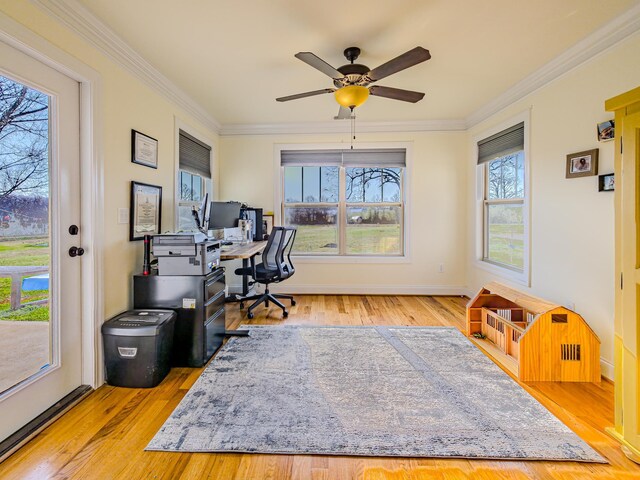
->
467;34;640;377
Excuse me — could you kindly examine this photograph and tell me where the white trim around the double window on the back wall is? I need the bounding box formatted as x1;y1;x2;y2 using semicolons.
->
273;142;413;264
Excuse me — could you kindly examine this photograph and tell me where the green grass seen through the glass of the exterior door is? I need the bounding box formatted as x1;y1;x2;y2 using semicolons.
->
0;237;49;321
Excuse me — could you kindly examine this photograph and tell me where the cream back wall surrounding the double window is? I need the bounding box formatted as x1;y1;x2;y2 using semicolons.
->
220;130;467;294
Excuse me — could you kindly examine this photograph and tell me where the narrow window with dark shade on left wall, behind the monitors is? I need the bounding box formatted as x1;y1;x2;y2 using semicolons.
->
176;130;212;232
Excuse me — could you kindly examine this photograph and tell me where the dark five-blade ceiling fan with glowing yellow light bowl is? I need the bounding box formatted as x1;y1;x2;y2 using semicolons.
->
276;47;431;119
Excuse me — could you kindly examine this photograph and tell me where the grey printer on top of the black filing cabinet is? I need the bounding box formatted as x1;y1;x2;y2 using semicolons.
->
151;233;220;275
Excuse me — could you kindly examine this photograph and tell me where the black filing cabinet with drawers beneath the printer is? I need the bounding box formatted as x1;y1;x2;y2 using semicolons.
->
133;268;225;367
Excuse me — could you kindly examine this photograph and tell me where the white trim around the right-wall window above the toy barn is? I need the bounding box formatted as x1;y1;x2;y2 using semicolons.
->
471;110;531;286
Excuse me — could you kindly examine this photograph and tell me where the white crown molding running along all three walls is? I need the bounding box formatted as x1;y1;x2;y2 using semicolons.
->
32;0;640;136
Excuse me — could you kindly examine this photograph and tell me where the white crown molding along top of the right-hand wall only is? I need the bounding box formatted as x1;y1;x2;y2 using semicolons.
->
466;1;640;128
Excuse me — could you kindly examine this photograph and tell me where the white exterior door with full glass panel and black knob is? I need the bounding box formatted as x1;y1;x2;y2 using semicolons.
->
0;42;82;441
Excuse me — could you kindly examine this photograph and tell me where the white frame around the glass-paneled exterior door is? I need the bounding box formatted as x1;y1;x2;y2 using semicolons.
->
0;12;104;388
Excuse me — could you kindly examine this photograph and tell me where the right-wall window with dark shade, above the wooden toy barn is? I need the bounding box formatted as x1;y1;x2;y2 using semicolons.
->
478;123;527;272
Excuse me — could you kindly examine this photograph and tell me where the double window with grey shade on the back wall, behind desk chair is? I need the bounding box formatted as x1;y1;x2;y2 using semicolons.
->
281;149;405;256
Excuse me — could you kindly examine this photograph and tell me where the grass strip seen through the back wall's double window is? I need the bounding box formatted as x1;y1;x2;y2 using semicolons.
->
293;225;400;255
